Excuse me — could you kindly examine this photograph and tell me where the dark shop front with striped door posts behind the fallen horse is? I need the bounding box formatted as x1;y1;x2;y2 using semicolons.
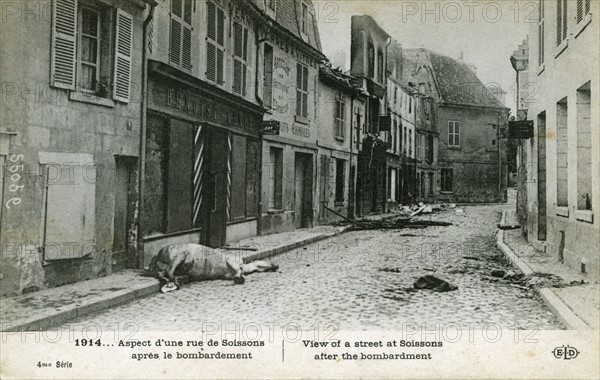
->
142;62;262;264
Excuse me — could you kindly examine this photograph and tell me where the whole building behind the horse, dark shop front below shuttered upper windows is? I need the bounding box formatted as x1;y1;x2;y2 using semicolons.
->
141;0;266;264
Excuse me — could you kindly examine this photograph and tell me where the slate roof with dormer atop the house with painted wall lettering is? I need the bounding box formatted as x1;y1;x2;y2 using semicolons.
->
251;0;322;51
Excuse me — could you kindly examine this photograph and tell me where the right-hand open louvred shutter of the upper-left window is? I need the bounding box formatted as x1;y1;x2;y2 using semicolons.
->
113;9;133;103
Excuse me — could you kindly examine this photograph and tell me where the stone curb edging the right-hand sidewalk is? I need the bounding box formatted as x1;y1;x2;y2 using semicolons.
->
496;211;592;330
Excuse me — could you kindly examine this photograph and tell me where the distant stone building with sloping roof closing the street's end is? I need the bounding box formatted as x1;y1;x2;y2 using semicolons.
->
402;49;509;202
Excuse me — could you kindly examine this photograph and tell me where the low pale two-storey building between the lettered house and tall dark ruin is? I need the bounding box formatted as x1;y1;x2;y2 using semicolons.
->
315;64;366;224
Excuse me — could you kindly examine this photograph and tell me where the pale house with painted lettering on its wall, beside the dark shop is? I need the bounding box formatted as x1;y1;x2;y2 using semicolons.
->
254;0;325;234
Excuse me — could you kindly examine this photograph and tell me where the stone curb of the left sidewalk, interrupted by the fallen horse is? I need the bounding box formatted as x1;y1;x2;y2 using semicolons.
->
2;227;347;332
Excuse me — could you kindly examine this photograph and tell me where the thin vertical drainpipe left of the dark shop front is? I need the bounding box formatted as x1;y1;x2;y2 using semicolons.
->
137;5;155;269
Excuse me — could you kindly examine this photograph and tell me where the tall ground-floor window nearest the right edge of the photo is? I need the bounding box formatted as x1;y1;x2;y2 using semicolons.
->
576;82;592;210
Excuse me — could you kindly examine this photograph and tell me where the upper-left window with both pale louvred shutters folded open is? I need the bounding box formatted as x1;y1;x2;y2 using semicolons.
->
50;0;133;103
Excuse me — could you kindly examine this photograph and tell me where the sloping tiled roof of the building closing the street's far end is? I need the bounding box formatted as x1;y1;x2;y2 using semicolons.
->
409;49;506;108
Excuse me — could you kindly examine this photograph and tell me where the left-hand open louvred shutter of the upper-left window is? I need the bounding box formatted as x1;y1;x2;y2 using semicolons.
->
50;0;77;90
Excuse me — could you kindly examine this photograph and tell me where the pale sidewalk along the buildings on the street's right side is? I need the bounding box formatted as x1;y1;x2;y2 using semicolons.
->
497;210;600;330
